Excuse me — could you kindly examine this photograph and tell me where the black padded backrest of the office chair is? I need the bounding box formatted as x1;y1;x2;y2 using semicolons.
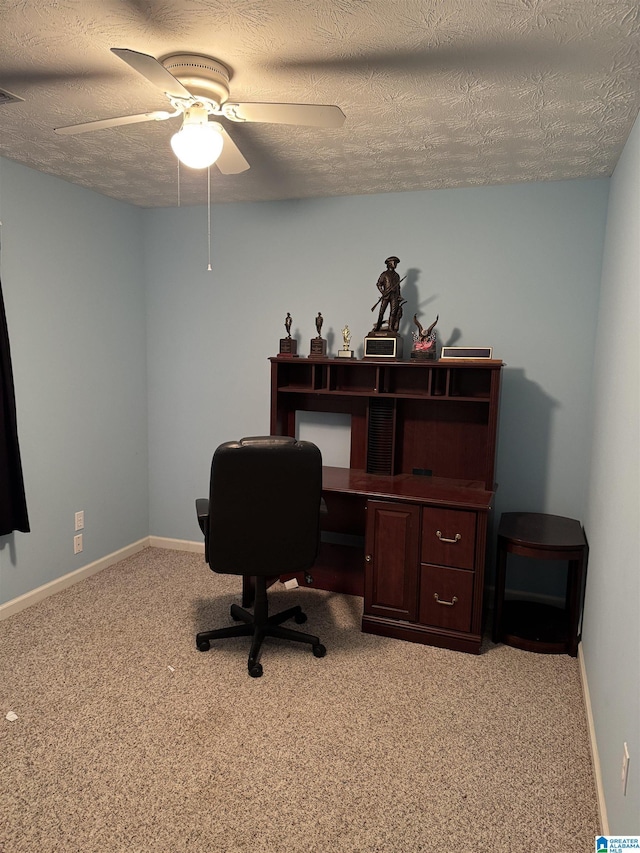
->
208;436;322;576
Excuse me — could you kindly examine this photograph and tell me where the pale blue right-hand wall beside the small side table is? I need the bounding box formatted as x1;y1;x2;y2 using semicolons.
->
583;111;640;835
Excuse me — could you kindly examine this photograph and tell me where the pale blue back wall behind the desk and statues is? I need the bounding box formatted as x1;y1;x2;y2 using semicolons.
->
144;180;608;539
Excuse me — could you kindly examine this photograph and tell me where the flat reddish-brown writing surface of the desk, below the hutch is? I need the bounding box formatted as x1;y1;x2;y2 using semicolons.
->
322;466;493;511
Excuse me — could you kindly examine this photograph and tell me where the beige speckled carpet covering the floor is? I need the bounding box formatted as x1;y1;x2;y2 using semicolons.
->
0;549;599;853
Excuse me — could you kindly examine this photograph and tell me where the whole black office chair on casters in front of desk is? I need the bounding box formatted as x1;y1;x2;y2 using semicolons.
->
196;436;327;678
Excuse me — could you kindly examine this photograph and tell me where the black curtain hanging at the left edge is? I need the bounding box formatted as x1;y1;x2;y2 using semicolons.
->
0;276;29;536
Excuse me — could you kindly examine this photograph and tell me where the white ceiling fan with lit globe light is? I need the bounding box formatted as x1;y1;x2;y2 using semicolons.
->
55;47;345;175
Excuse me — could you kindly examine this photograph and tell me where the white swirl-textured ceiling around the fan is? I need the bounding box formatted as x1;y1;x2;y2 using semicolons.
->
0;0;640;207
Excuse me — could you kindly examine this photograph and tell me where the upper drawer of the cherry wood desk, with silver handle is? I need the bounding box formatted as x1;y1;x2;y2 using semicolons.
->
420;507;476;569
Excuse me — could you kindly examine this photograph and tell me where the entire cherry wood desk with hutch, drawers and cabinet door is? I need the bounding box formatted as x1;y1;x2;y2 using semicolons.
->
270;357;502;654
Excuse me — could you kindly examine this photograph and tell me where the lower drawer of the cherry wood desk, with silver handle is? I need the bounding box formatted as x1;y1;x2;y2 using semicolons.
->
419;564;474;631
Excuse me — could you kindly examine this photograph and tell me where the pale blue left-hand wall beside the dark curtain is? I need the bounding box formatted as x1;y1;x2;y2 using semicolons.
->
0;160;149;603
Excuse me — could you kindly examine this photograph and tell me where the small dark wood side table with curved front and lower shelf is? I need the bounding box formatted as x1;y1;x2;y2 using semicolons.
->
493;512;587;657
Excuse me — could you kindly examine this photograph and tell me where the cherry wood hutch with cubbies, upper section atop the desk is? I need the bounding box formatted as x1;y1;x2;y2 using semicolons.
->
271;357;502;489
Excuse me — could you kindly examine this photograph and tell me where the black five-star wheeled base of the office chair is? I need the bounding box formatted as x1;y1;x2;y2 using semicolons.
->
196;576;327;678
